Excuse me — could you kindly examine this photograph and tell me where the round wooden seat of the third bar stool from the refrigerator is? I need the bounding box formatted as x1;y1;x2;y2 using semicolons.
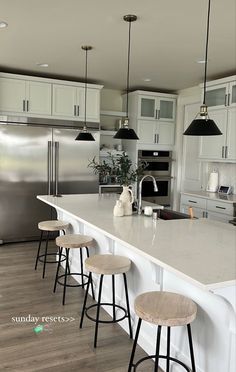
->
85;254;131;275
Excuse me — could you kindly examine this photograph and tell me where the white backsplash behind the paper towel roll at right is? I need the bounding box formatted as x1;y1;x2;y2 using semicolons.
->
206;163;236;194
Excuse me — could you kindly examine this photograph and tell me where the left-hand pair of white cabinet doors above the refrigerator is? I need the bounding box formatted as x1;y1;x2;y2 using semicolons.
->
0;77;51;115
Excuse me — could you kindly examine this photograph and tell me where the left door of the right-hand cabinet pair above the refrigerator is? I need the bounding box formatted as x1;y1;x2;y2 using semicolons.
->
52;84;78;120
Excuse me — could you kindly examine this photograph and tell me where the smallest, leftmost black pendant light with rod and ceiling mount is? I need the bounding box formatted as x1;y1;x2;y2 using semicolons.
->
75;45;95;141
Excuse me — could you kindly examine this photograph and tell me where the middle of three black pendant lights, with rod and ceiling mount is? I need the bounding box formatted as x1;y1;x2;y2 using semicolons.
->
114;14;139;140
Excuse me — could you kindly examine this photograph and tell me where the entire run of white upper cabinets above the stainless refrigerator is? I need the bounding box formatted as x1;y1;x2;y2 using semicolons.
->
0;73;102;122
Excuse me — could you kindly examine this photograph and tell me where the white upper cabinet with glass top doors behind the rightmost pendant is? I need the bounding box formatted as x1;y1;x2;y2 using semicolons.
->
199;76;236;162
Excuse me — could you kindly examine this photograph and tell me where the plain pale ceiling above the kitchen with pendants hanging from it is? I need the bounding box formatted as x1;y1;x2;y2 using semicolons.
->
0;0;236;91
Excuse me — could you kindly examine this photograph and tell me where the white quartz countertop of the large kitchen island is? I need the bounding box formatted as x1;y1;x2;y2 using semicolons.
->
37;194;236;290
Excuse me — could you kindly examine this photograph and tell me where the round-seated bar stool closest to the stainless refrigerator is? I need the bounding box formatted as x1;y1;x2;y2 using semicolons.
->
34;220;69;278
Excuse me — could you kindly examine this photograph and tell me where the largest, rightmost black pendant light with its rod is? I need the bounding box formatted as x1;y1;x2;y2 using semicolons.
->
184;0;222;136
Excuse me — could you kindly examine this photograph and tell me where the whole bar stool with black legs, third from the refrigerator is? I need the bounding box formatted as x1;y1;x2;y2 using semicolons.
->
80;254;132;348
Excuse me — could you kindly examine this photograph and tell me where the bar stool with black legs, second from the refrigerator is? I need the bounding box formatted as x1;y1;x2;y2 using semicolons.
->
53;234;95;305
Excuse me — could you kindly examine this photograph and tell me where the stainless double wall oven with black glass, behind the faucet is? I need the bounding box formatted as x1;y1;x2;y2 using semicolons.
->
138;150;172;206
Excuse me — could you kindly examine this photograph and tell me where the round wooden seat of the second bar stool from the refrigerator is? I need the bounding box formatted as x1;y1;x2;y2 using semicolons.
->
56;234;94;248
